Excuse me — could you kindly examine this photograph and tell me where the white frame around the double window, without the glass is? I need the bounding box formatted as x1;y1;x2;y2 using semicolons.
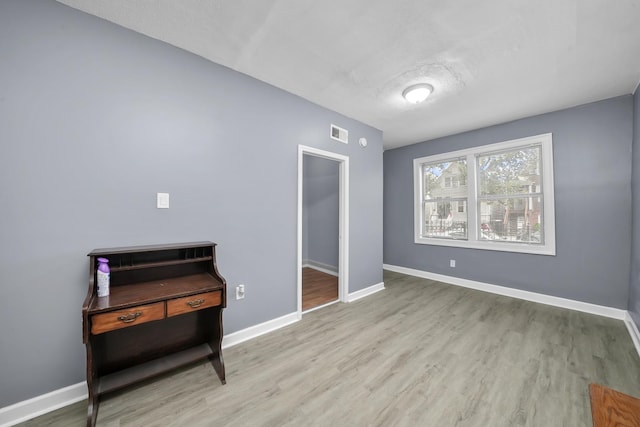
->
413;133;556;255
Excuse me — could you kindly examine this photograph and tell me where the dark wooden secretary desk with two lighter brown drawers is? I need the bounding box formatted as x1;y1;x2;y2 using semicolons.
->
82;242;227;426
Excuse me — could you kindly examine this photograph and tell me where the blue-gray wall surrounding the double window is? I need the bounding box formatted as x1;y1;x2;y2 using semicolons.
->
384;95;633;309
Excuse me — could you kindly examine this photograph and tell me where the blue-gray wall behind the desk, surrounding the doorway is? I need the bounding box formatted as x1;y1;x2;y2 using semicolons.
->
0;0;382;407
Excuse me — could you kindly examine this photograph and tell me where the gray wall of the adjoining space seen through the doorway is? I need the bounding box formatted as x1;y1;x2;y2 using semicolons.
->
303;155;340;272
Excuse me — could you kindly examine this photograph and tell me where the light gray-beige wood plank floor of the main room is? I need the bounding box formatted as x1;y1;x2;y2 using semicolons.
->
15;272;640;427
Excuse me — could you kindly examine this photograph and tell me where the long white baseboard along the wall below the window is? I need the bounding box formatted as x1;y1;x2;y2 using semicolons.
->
383;264;628;320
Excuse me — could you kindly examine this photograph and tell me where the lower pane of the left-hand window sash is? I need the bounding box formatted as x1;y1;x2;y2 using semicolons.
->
422;199;467;240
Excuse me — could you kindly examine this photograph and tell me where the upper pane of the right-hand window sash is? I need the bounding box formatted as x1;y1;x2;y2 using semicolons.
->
477;146;542;196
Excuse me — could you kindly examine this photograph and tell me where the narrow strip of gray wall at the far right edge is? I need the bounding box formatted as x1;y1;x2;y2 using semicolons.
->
628;88;640;329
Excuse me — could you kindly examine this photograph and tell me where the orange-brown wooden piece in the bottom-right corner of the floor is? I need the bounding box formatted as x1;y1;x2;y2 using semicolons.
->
589;384;640;427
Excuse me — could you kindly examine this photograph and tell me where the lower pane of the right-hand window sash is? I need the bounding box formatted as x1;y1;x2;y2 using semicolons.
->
478;196;544;244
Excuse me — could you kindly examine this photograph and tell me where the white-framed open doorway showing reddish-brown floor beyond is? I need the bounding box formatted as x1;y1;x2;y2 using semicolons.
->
297;145;349;318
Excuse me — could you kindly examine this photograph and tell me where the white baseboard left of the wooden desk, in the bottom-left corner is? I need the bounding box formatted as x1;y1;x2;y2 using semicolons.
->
0;381;88;427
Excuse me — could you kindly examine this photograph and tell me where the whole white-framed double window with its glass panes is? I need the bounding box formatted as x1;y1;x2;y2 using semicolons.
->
414;134;555;255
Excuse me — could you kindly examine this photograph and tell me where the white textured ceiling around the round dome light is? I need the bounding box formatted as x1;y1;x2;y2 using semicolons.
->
58;0;640;149
